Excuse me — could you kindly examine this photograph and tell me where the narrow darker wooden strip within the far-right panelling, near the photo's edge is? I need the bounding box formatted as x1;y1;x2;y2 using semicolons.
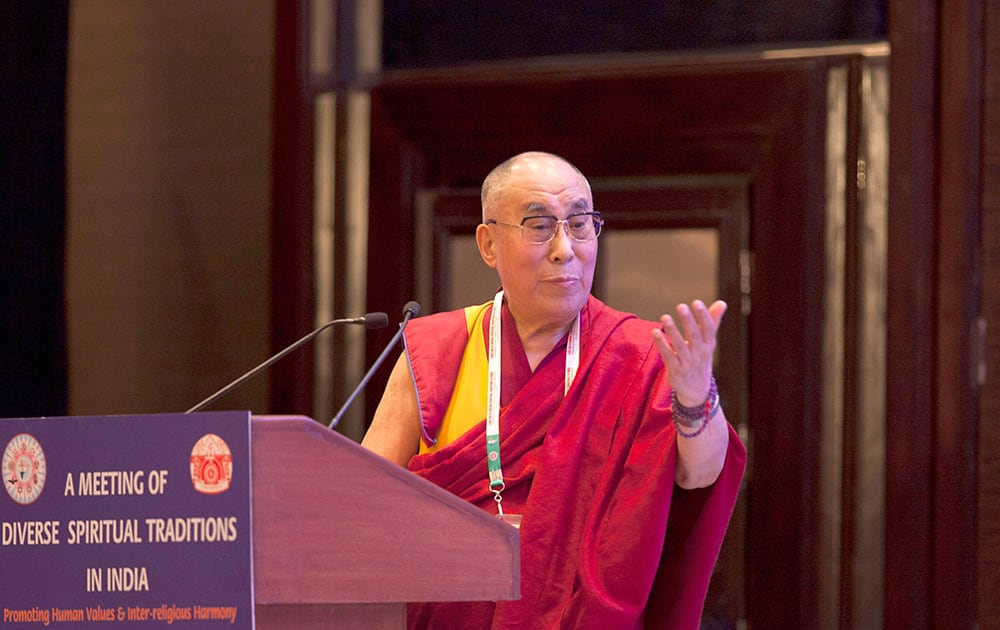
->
932;2;984;627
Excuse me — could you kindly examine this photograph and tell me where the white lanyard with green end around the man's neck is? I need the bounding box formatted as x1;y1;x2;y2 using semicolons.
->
486;291;580;525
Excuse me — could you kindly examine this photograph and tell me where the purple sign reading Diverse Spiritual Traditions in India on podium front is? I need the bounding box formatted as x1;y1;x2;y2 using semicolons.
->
0;411;254;628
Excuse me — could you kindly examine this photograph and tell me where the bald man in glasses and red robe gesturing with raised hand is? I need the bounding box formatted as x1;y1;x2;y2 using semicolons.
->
362;152;746;628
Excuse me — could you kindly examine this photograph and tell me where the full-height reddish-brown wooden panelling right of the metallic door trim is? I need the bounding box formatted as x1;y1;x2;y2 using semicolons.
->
885;0;995;629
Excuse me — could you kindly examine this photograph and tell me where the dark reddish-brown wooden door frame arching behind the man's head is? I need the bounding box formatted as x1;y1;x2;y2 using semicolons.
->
369;50;845;627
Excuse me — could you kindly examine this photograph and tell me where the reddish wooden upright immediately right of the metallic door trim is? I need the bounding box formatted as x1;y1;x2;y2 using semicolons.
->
885;2;938;628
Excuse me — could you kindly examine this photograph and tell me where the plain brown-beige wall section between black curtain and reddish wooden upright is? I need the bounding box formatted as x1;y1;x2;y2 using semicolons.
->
66;0;274;415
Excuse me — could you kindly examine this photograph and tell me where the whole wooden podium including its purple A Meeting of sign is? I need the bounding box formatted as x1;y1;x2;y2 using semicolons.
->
0;411;520;630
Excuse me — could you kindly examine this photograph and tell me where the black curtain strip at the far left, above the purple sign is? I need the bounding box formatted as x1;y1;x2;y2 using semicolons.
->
0;0;69;417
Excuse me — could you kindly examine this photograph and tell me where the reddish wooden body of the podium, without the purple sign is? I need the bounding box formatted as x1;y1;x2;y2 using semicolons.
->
251;416;520;630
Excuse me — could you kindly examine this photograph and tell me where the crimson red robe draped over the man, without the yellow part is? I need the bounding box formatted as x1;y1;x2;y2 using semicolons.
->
404;297;746;629
